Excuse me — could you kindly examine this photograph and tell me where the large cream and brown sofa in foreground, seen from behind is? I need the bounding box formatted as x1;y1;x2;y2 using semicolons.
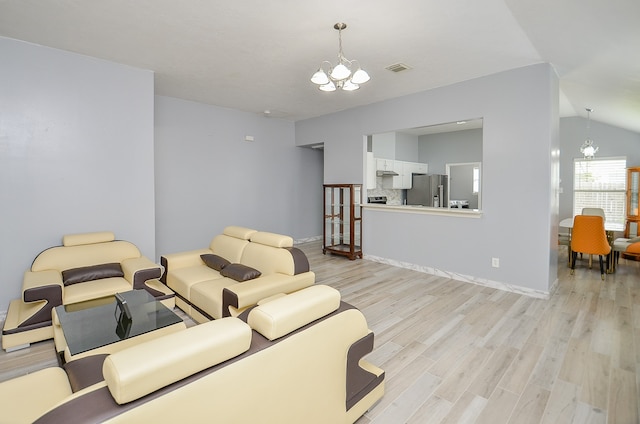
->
0;285;384;424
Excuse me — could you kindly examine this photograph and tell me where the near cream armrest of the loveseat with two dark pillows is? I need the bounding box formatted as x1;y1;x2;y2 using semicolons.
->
222;271;315;317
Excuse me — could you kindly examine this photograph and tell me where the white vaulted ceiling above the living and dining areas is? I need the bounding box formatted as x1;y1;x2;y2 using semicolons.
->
0;0;640;133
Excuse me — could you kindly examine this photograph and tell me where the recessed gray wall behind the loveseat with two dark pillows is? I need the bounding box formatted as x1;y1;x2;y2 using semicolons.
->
155;96;323;255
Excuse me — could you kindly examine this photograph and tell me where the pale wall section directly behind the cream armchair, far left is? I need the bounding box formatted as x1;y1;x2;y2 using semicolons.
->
0;37;155;311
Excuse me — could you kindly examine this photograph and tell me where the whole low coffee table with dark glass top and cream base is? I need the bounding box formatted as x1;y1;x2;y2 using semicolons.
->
52;290;186;363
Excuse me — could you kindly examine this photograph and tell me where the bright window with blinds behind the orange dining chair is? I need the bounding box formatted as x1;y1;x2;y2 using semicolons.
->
573;158;627;225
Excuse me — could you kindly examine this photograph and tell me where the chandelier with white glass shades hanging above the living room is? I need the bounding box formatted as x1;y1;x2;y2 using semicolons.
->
311;22;370;91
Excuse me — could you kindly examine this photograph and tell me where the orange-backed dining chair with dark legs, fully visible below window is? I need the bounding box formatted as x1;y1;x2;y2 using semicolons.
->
571;215;611;280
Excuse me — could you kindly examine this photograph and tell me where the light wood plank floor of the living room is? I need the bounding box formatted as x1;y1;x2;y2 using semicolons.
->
0;242;640;424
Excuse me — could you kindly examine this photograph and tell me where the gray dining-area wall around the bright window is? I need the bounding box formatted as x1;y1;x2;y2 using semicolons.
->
560;116;640;222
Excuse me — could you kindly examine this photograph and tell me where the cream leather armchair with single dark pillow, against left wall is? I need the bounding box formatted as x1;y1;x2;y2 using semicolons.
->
2;231;173;350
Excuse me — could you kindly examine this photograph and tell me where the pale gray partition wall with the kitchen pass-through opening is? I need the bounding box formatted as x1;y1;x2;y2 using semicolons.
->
296;64;558;293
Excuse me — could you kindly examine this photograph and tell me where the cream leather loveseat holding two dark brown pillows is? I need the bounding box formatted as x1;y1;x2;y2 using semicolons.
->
160;226;315;323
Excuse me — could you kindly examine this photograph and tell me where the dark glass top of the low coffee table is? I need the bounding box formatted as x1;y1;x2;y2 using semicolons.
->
55;290;182;355
